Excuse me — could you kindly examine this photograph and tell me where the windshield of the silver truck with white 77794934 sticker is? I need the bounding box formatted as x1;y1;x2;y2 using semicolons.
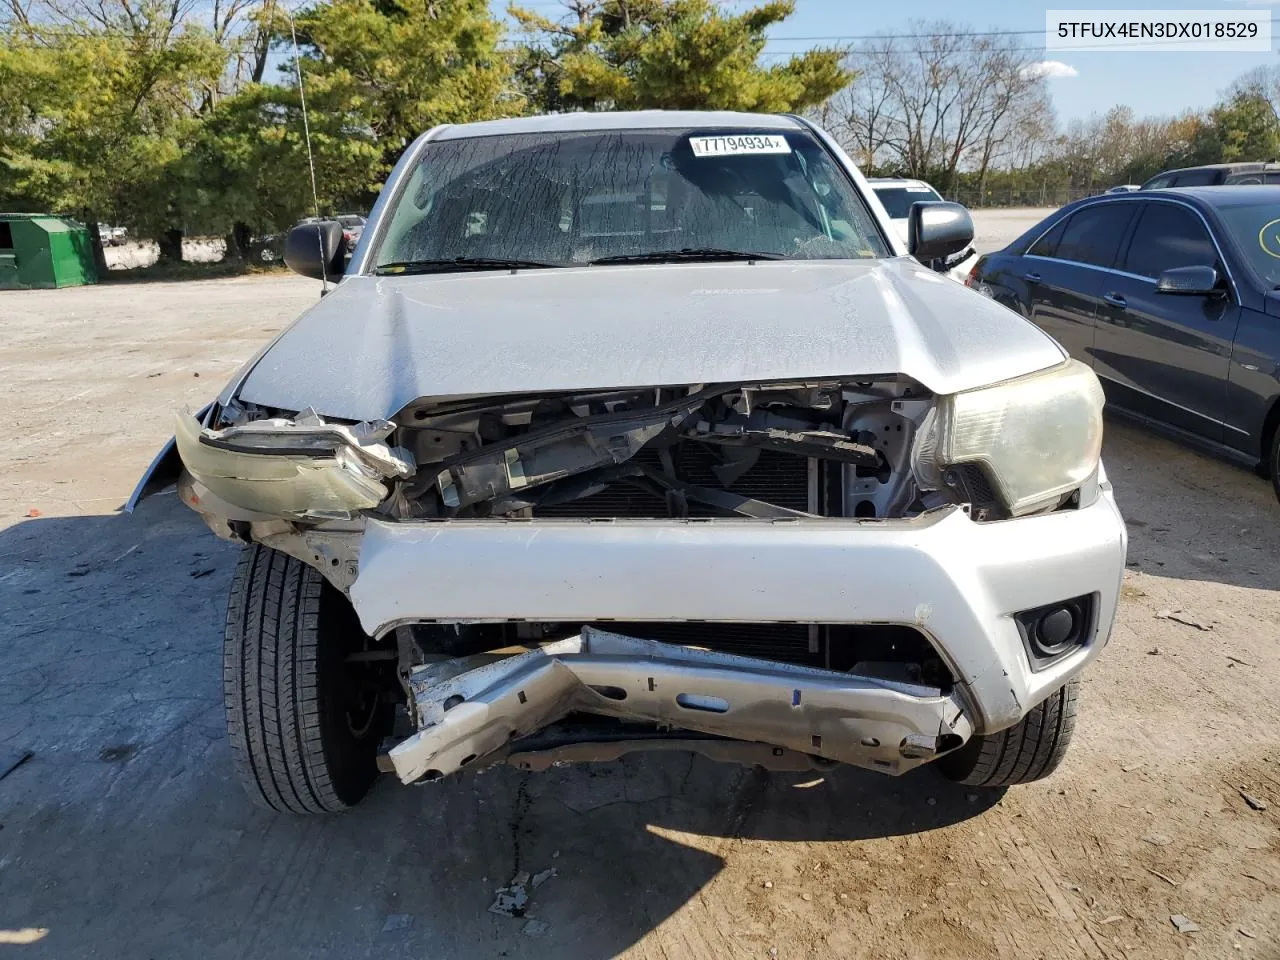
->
376;128;888;273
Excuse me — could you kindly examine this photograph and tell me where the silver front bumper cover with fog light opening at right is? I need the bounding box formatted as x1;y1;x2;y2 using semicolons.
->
351;483;1126;733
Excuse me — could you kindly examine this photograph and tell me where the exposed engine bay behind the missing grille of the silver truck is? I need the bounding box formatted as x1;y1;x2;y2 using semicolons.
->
380;378;952;520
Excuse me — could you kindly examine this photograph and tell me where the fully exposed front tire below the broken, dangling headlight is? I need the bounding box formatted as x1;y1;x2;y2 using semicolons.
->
223;544;393;814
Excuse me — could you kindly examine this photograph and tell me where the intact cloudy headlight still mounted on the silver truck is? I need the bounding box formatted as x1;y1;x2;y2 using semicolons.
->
913;360;1103;517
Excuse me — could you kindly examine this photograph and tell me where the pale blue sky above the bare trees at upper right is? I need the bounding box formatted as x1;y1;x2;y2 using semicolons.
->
494;0;1280;122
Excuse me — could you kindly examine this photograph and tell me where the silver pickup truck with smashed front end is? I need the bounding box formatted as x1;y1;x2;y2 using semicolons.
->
131;111;1125;813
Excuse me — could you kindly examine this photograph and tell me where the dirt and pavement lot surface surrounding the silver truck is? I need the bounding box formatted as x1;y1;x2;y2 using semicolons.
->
0;211;1280;960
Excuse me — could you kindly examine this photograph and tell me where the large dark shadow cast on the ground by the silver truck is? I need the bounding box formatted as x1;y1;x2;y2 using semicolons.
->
0;506;1000;957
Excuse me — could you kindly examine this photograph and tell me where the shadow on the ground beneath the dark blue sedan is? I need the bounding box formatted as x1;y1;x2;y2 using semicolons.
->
1102;417;1280;590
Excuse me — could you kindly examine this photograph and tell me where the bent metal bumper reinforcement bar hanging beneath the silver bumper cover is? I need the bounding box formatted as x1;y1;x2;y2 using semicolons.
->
390;627;972;783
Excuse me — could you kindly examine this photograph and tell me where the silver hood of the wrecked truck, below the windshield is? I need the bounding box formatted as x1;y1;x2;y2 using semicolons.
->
230;257;1065;420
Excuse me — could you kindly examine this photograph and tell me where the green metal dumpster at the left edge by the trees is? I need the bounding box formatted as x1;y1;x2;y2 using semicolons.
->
0;214;97;289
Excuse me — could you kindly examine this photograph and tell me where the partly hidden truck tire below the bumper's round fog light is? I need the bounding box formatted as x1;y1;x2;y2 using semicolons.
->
938;680;1079;787
